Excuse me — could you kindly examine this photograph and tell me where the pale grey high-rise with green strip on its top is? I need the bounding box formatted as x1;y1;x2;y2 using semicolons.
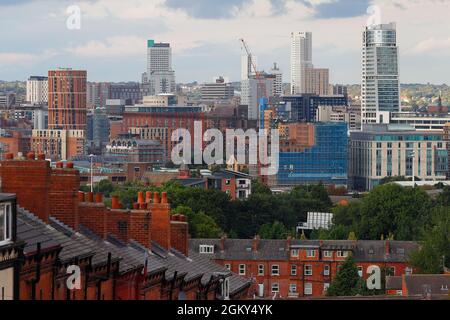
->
146;40;176;95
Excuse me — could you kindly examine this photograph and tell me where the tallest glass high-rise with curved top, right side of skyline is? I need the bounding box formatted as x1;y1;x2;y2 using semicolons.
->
361;23;400;124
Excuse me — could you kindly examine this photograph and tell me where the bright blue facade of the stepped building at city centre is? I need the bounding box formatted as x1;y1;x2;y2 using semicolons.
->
277;123;348;186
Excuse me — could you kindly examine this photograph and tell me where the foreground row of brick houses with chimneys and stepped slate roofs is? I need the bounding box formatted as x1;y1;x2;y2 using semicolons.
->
0;153;250;300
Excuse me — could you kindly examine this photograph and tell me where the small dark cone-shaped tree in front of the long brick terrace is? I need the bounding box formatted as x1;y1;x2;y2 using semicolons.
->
327;255;361;296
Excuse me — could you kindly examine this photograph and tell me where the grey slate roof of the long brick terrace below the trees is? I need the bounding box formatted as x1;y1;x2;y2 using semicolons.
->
189;239;418;262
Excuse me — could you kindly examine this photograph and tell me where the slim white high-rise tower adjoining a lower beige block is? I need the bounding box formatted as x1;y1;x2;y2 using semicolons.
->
291;32;313;94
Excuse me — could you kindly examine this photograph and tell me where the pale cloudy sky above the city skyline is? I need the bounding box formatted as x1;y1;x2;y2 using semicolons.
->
0;0;450;84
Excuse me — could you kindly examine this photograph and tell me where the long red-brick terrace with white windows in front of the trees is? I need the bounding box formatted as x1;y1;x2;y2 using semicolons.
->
190;236;417;298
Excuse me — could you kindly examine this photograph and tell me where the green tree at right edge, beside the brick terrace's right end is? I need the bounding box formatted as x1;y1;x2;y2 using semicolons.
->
410;207;450;274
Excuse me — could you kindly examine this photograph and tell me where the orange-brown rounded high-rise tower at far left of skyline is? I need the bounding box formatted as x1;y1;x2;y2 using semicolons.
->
48;69;87;130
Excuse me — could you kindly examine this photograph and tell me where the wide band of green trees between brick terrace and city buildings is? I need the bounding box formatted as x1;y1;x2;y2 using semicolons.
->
82;181;450;273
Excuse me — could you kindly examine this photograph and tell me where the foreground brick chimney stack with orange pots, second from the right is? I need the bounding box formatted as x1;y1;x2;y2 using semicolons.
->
149;192;171;249
